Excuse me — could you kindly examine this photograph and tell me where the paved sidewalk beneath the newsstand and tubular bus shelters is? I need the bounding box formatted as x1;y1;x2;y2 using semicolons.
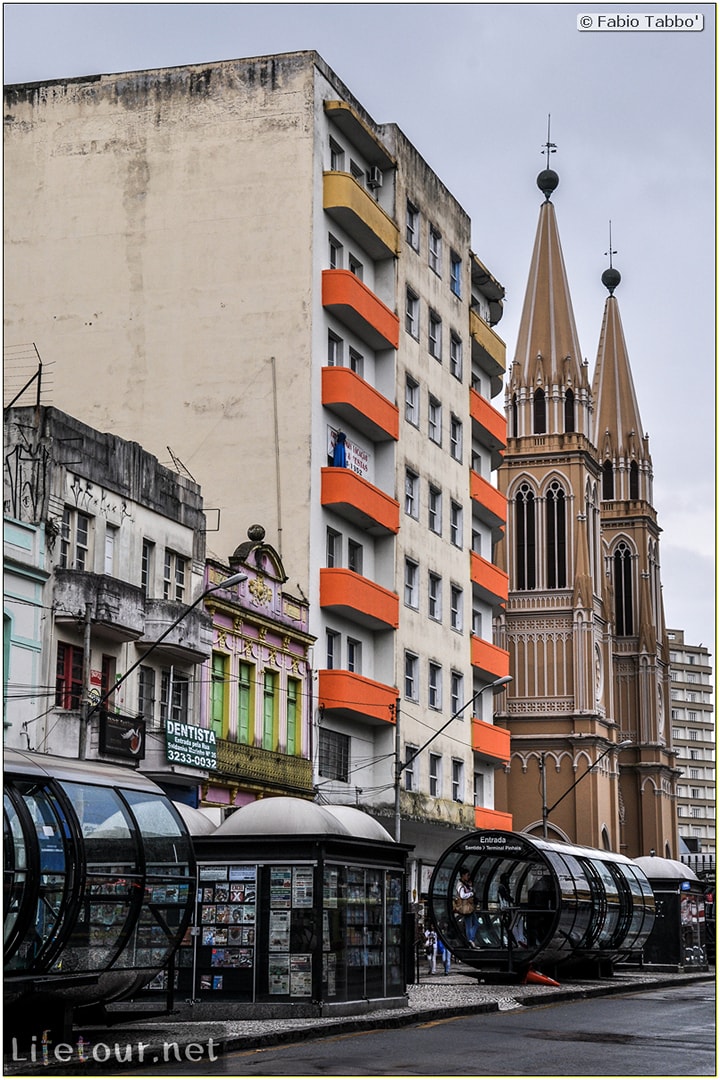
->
3;964;715;1076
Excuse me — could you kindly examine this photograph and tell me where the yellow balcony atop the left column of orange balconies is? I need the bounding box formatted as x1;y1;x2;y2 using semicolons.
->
323;173;399;259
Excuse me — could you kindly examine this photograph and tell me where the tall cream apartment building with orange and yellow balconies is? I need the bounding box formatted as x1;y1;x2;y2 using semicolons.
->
5;52;512;887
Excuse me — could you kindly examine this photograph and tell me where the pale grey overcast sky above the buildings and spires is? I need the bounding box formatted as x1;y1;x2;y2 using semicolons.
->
4;2;716;651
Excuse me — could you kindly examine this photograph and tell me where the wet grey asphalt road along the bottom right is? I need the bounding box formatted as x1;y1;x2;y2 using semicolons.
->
123;983;716;1080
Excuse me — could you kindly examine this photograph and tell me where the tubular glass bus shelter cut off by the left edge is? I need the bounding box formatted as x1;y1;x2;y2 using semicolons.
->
3;748;195;1034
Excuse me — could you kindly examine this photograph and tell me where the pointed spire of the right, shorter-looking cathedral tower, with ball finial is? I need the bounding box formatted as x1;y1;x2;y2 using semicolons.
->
593;266;652;502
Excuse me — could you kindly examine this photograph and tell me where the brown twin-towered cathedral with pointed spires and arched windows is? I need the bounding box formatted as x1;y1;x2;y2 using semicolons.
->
495;159;679;859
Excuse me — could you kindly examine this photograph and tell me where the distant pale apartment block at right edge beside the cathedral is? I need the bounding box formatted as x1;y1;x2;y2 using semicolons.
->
667;630;716;869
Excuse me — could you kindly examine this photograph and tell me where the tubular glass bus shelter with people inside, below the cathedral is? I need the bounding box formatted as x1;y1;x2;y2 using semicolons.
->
427;831;655;974
